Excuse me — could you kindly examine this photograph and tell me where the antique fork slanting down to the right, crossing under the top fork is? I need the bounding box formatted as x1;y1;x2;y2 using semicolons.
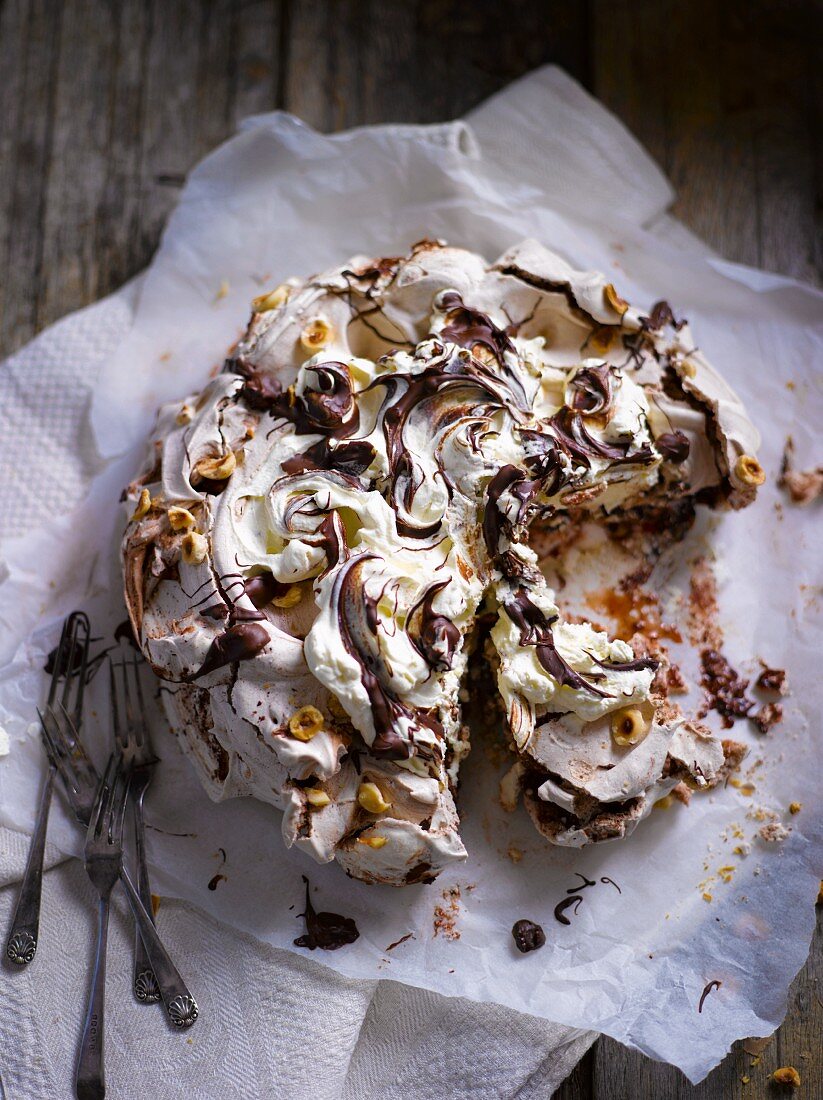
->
41;707;198;1027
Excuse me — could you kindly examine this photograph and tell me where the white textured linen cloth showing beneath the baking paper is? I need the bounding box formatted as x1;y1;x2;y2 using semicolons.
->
0;67;682;1100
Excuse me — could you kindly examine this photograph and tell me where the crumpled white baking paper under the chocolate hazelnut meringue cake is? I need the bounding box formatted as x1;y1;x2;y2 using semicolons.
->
0;64;823;1081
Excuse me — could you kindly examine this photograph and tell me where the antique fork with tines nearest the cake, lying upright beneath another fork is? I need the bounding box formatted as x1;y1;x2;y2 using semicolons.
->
109;653;160;1004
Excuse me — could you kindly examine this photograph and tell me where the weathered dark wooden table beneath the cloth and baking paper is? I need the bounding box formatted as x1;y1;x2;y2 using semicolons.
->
0;0;823;1100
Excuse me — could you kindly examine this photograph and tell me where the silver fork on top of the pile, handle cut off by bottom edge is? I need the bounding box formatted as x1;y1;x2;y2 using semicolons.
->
75;754;129;1100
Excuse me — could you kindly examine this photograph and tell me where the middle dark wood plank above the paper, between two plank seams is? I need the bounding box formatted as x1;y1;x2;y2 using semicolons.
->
285;0;589;130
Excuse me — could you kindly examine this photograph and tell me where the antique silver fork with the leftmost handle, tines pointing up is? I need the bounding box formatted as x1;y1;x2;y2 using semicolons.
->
6;612;89;966
